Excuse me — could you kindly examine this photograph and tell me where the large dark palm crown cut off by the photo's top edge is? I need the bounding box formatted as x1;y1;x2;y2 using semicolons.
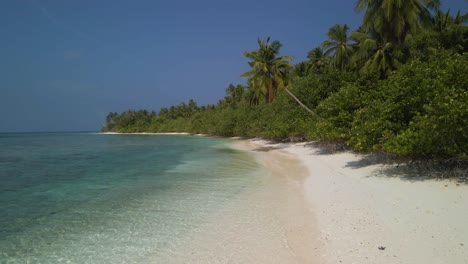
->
356;0;440;46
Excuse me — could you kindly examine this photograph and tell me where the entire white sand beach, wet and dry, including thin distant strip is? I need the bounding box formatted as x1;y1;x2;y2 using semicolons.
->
103;133;468;264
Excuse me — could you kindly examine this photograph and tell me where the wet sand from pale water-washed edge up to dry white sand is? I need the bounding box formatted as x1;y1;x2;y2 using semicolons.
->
159;141;322;264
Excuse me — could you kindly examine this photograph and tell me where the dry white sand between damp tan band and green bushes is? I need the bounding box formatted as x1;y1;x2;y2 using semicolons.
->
250;140;468;264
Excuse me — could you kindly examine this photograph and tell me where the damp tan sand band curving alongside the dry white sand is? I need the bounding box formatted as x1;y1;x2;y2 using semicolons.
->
233;138;326;263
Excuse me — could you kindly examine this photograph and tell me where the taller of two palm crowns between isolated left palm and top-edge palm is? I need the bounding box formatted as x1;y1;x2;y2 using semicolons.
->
322;24;352;70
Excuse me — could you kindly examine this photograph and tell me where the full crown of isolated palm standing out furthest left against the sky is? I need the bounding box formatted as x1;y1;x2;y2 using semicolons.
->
241;37;292;103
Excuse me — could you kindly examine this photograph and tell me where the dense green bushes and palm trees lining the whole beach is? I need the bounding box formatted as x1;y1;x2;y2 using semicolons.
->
103;0;468;160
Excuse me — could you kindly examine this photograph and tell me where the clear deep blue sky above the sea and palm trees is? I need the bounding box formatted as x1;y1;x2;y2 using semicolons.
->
0;0;468;132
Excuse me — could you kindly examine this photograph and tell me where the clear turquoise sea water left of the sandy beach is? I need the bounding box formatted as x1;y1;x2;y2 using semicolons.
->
0;133;259;263
